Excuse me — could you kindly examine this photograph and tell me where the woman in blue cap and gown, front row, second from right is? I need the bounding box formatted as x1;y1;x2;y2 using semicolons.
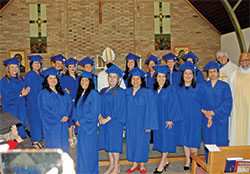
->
177;61;202;170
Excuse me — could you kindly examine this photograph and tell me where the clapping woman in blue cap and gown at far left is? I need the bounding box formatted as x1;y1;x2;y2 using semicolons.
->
0;58;30;138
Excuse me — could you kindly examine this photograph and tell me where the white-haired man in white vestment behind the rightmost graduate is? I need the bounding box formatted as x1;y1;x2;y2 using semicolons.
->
216;51;238;83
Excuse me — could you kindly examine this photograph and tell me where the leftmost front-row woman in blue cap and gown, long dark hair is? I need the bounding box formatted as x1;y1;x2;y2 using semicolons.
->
38;67;72;152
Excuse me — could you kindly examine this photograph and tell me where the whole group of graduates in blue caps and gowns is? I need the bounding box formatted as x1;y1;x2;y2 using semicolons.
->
0;51;232;174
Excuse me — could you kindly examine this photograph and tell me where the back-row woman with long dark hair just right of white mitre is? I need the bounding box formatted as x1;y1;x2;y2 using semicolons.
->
123;53;140;87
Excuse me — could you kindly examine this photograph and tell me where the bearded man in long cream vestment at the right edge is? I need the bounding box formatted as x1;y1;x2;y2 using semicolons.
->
229;53;250;146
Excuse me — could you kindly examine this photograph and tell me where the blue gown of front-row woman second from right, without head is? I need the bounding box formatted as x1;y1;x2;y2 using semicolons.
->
177;85;202;148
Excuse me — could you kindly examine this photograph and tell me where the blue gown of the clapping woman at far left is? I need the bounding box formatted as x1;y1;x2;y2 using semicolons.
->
0;77;27;138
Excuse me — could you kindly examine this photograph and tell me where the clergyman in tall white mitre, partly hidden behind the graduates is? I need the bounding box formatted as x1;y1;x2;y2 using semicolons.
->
97;47;126;92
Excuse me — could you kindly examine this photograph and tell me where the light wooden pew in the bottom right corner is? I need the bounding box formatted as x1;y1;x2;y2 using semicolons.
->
191;146;250;174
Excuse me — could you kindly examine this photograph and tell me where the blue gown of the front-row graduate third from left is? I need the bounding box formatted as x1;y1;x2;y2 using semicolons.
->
99;87;126;153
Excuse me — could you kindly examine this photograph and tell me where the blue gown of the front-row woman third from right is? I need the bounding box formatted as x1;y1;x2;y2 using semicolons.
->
153;85;182;153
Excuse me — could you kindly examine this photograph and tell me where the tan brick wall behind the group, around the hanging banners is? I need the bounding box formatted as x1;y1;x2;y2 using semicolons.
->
0;0;220;77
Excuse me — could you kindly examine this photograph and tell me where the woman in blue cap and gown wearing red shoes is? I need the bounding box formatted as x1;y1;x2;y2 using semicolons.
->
126;68;158;173
